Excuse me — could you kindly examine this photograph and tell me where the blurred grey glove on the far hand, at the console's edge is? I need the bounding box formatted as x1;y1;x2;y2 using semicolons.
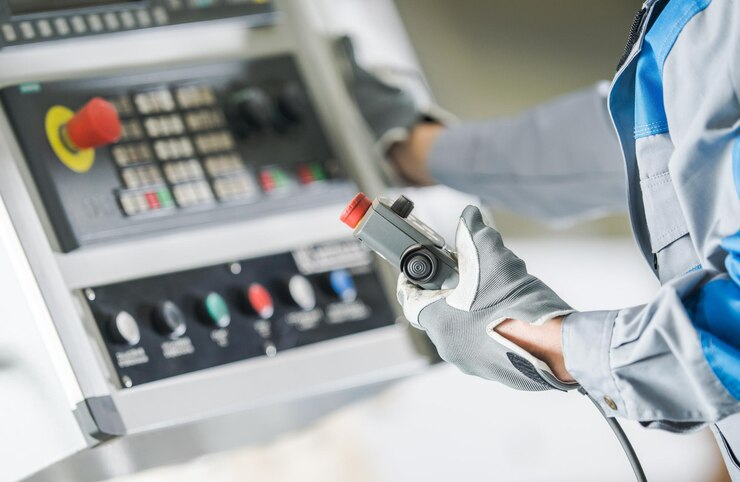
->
336;35;454;154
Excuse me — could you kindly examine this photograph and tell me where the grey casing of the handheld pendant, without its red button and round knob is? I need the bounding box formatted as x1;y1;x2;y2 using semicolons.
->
353;197;458;290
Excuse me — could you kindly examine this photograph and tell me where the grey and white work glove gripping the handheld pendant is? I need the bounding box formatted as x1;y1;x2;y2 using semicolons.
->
397;206;578;391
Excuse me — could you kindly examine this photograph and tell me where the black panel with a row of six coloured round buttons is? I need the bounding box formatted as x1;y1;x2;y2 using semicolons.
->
83;239;394;388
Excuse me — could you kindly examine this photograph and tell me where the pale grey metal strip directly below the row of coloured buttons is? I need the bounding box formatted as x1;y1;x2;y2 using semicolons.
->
113;325;427;433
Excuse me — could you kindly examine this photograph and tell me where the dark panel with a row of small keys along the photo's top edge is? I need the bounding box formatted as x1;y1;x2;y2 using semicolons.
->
0;0;274;48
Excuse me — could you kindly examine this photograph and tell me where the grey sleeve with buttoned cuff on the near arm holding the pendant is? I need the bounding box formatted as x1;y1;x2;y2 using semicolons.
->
562;270;740;432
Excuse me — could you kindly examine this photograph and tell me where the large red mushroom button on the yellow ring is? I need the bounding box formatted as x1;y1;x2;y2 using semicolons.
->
64;97;121;150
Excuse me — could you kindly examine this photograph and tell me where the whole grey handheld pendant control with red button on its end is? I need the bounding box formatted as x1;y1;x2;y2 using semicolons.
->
340;193;458;290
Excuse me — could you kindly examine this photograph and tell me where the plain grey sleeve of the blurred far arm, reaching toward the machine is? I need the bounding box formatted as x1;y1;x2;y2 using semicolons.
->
428;82;627;221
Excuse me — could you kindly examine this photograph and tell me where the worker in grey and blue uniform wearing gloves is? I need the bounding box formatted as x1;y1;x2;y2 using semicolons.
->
340;0;740;481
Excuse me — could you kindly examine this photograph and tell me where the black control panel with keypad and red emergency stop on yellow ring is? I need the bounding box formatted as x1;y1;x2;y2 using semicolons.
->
2;55;352;252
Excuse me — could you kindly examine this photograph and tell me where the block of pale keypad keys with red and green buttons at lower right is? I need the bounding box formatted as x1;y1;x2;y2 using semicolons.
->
108;85;327;216
